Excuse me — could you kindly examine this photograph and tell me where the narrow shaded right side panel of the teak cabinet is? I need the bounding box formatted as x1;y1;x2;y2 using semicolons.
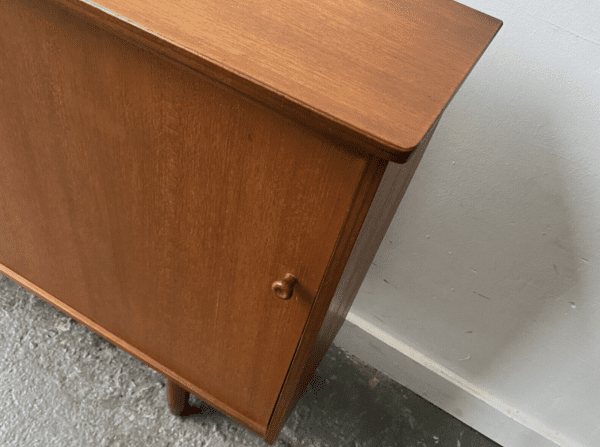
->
266;119;439;442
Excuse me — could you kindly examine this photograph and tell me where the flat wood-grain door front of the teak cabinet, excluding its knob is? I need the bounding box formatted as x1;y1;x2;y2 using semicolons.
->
0;1;378;434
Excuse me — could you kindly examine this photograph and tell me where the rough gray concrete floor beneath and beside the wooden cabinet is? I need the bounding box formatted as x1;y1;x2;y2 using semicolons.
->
0;275;497;447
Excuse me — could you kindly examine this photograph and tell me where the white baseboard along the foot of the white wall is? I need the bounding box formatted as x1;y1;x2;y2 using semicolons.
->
334;310;583;447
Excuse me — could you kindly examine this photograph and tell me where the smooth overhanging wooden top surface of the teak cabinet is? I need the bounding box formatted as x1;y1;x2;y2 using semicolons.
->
70;0;502;153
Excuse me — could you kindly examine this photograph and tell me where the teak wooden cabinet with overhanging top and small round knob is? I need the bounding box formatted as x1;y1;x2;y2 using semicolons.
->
0;0;501;443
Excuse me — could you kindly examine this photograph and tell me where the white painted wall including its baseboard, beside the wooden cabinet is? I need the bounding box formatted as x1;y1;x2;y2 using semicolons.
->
336;0;600;447
